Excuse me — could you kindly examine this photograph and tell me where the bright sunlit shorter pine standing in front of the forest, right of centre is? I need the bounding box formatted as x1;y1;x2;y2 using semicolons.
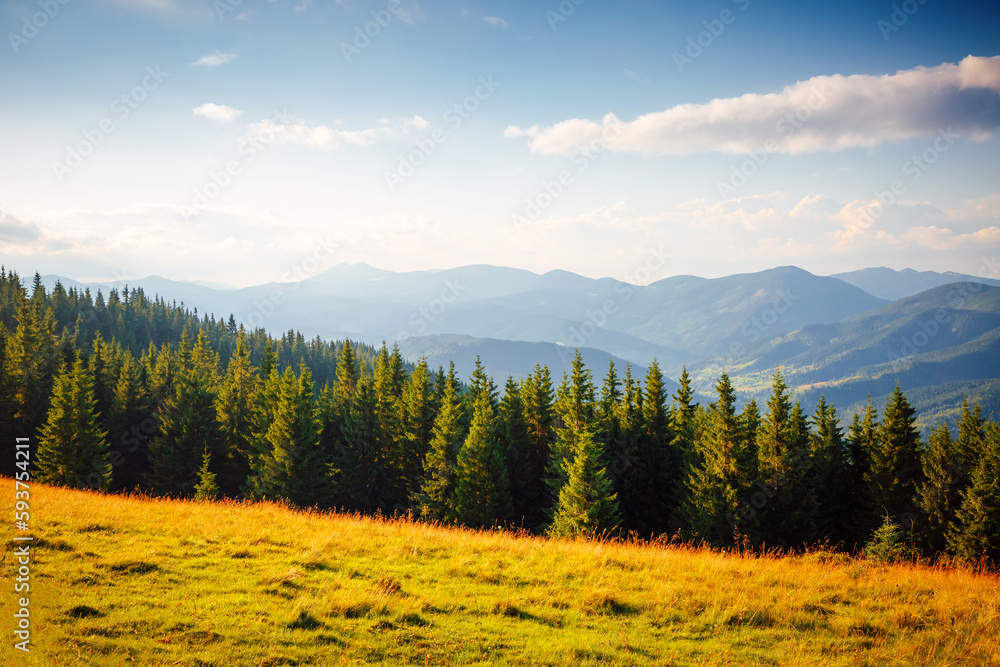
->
549;428;619;537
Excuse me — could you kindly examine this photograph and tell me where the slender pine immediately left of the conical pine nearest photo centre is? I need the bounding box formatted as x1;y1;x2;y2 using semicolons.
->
413;362;465;521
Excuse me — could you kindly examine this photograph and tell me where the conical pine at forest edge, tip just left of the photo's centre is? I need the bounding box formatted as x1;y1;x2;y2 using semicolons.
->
455;382;511;527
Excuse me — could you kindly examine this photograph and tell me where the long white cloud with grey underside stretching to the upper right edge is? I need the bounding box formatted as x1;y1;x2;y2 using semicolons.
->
504;56;1000;155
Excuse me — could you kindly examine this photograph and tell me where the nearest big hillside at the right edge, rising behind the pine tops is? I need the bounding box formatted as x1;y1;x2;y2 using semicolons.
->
694;283;1000;426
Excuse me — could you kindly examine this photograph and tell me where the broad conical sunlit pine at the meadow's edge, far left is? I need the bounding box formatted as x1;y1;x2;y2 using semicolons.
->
35;360;111;490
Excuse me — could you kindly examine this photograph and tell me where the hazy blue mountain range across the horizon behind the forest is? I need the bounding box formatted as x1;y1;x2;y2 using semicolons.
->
43;264;1000;428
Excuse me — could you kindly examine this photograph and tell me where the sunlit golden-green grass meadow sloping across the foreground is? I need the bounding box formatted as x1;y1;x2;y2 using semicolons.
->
0;479;1000;667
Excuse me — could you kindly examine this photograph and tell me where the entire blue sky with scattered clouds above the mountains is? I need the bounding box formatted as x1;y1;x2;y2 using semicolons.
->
0;0;1000;286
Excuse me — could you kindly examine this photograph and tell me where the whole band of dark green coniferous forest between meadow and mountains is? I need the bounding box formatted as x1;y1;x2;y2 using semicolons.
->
0;271;1000;563
